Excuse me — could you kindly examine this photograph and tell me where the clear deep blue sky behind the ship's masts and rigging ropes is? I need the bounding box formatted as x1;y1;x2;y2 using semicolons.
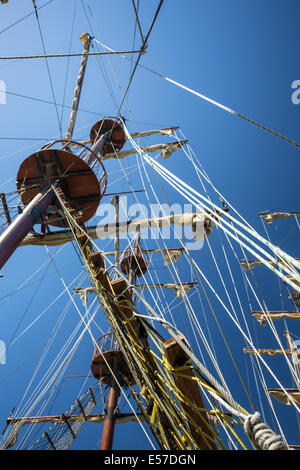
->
0;0;300;448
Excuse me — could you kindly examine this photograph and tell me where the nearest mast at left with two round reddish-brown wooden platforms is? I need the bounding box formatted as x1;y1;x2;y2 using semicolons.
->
0;33;126;269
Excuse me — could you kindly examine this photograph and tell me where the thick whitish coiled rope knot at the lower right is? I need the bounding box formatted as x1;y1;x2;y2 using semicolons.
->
244;412;288;450
